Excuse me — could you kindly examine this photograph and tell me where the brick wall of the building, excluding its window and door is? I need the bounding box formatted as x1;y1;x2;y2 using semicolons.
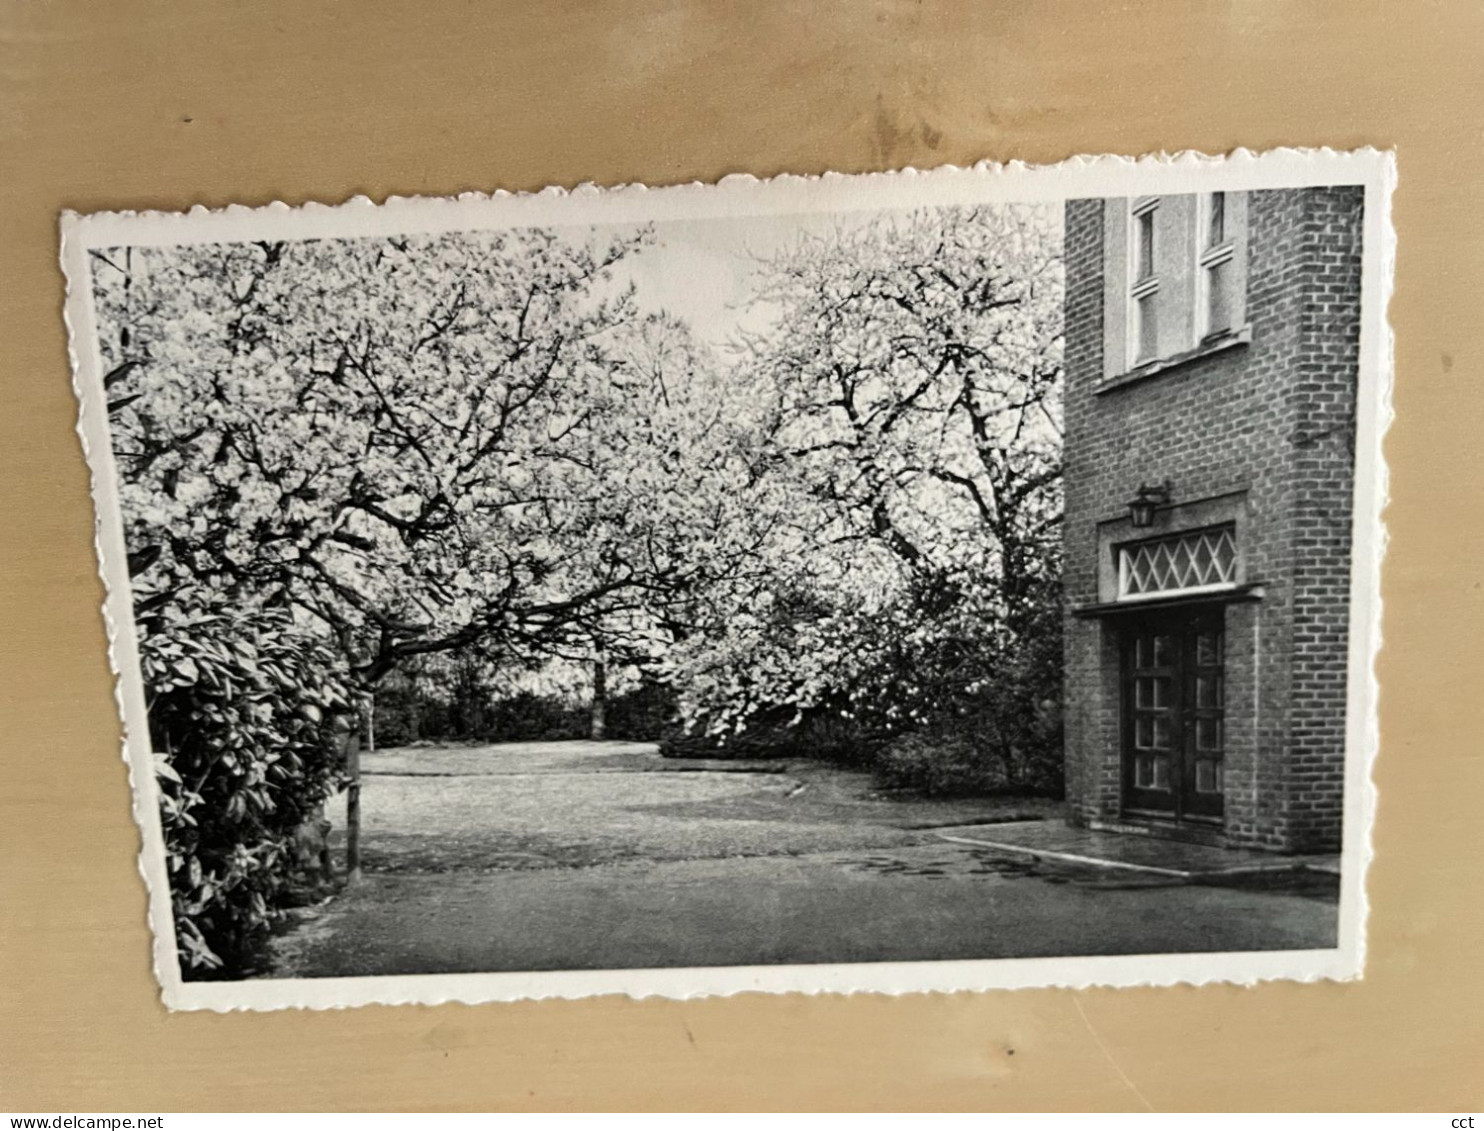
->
1064;189;1362;850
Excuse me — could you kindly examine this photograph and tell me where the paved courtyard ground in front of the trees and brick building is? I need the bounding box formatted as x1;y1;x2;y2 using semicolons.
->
261;742;1336;977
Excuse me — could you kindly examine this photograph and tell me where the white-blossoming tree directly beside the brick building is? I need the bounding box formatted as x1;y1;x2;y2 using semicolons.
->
655;206;1063;787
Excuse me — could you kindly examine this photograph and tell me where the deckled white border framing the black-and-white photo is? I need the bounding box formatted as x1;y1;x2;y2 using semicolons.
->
61;148;1396;1011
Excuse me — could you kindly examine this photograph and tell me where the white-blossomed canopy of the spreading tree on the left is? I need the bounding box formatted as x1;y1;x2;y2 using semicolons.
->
95;230;733;684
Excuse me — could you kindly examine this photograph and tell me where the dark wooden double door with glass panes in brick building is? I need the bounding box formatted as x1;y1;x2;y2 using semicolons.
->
1120;606;1226;824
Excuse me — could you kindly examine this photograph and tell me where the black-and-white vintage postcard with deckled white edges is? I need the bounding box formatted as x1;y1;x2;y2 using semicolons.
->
62;150;1393;1009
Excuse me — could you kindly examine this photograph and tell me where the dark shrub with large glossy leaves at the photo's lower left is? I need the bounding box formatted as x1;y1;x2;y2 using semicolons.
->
139;610;350;978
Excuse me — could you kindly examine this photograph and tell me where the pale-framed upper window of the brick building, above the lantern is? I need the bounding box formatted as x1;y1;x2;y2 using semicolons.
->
1104;193;1247;377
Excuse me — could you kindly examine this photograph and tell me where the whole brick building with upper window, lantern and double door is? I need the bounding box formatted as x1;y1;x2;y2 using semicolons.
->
1066;187;1364;852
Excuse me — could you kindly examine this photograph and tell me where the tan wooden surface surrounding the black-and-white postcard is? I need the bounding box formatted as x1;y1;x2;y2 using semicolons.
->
0;0;1484;1110
